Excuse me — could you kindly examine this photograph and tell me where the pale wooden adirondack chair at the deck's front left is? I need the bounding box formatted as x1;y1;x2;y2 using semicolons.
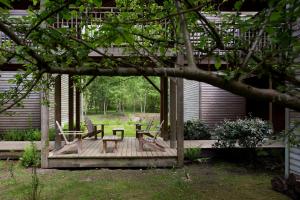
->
56;121;84;153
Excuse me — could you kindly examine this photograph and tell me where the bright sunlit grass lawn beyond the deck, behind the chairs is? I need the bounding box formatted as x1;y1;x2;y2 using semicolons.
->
88;113;159;137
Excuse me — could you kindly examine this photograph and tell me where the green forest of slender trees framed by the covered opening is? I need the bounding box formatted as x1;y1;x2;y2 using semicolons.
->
84;77;160;114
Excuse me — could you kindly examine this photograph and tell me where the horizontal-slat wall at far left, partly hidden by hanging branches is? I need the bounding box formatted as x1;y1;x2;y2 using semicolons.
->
0;71;41;133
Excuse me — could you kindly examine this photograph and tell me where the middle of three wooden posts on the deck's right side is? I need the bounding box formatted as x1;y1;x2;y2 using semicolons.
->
170;78;176;148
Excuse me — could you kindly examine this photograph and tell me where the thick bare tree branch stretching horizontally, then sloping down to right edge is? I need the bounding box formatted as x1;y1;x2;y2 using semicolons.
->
47;64;300;111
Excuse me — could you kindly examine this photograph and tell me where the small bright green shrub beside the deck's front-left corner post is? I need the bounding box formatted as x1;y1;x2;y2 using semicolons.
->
20;142;40;168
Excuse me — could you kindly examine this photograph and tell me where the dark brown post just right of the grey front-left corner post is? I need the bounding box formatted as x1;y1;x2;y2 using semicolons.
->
54;75;61;150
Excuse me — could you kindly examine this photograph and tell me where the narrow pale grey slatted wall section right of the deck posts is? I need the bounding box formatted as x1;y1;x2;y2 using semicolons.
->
183;79;200;121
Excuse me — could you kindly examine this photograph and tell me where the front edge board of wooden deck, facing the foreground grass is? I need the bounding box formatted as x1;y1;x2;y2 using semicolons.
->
48;158;177;168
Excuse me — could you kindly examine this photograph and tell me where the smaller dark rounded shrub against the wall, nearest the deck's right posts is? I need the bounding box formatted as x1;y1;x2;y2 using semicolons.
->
184;120;211;140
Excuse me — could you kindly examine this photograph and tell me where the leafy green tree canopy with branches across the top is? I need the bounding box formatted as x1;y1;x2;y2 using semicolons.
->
0;0;300;112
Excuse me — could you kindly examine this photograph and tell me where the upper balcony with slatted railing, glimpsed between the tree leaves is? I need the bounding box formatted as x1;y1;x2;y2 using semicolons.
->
0;7;269;64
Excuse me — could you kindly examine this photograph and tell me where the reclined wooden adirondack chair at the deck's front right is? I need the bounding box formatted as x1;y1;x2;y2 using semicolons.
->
138;121;165;151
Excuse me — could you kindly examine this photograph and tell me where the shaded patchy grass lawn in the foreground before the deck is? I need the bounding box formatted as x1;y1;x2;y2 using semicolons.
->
0;161;288;200
